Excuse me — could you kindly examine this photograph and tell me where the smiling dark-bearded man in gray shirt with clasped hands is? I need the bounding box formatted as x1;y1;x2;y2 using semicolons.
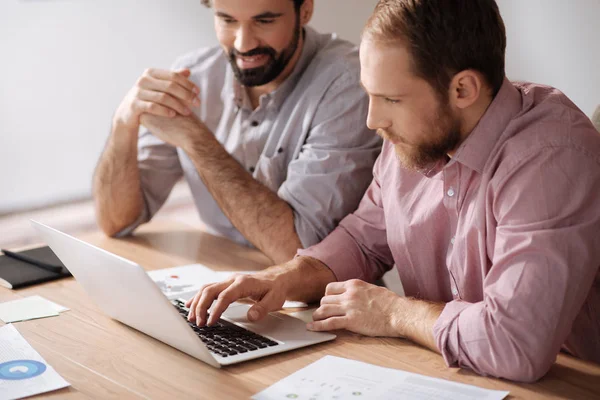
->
94;0;381;263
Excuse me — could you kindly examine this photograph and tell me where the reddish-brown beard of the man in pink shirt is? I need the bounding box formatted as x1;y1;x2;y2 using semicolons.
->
378;101;461;172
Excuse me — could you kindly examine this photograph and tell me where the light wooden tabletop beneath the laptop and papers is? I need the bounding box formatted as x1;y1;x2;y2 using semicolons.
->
0;222;600;399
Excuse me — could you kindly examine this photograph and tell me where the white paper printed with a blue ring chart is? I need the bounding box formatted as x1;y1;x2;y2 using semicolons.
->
0;325;70;400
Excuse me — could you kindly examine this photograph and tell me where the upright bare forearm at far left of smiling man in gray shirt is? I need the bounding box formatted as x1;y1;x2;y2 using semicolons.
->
93;120;144;236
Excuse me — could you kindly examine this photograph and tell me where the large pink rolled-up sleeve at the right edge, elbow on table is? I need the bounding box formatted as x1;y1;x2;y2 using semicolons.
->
433;146;600;382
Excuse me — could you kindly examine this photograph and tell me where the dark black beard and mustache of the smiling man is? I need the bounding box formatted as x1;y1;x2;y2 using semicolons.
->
229;17;300;87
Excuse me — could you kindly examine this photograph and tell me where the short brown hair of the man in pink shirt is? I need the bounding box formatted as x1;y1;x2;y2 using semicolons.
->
363;0;506;98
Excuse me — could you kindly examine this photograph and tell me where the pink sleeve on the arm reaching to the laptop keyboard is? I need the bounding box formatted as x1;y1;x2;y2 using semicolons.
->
297;151;394;282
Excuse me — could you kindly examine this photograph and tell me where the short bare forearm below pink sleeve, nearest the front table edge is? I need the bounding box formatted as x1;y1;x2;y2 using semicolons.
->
395;297;444;353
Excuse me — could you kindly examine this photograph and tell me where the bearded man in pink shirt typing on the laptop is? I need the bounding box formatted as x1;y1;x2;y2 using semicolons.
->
188;0;600;382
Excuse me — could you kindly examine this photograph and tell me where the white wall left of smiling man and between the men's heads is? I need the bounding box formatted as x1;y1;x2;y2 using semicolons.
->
0;0;376;214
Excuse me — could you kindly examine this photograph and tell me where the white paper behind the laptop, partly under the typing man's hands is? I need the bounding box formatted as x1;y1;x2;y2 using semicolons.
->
148;264;307;308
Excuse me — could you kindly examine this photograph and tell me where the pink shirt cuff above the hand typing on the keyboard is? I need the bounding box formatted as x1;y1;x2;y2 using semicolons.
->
296;227;367;282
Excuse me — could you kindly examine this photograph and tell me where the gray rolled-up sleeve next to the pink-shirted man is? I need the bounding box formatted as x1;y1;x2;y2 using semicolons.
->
277;70;381;247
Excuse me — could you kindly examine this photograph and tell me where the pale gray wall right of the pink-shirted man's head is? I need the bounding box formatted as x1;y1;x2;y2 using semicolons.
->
496;0;600;117
